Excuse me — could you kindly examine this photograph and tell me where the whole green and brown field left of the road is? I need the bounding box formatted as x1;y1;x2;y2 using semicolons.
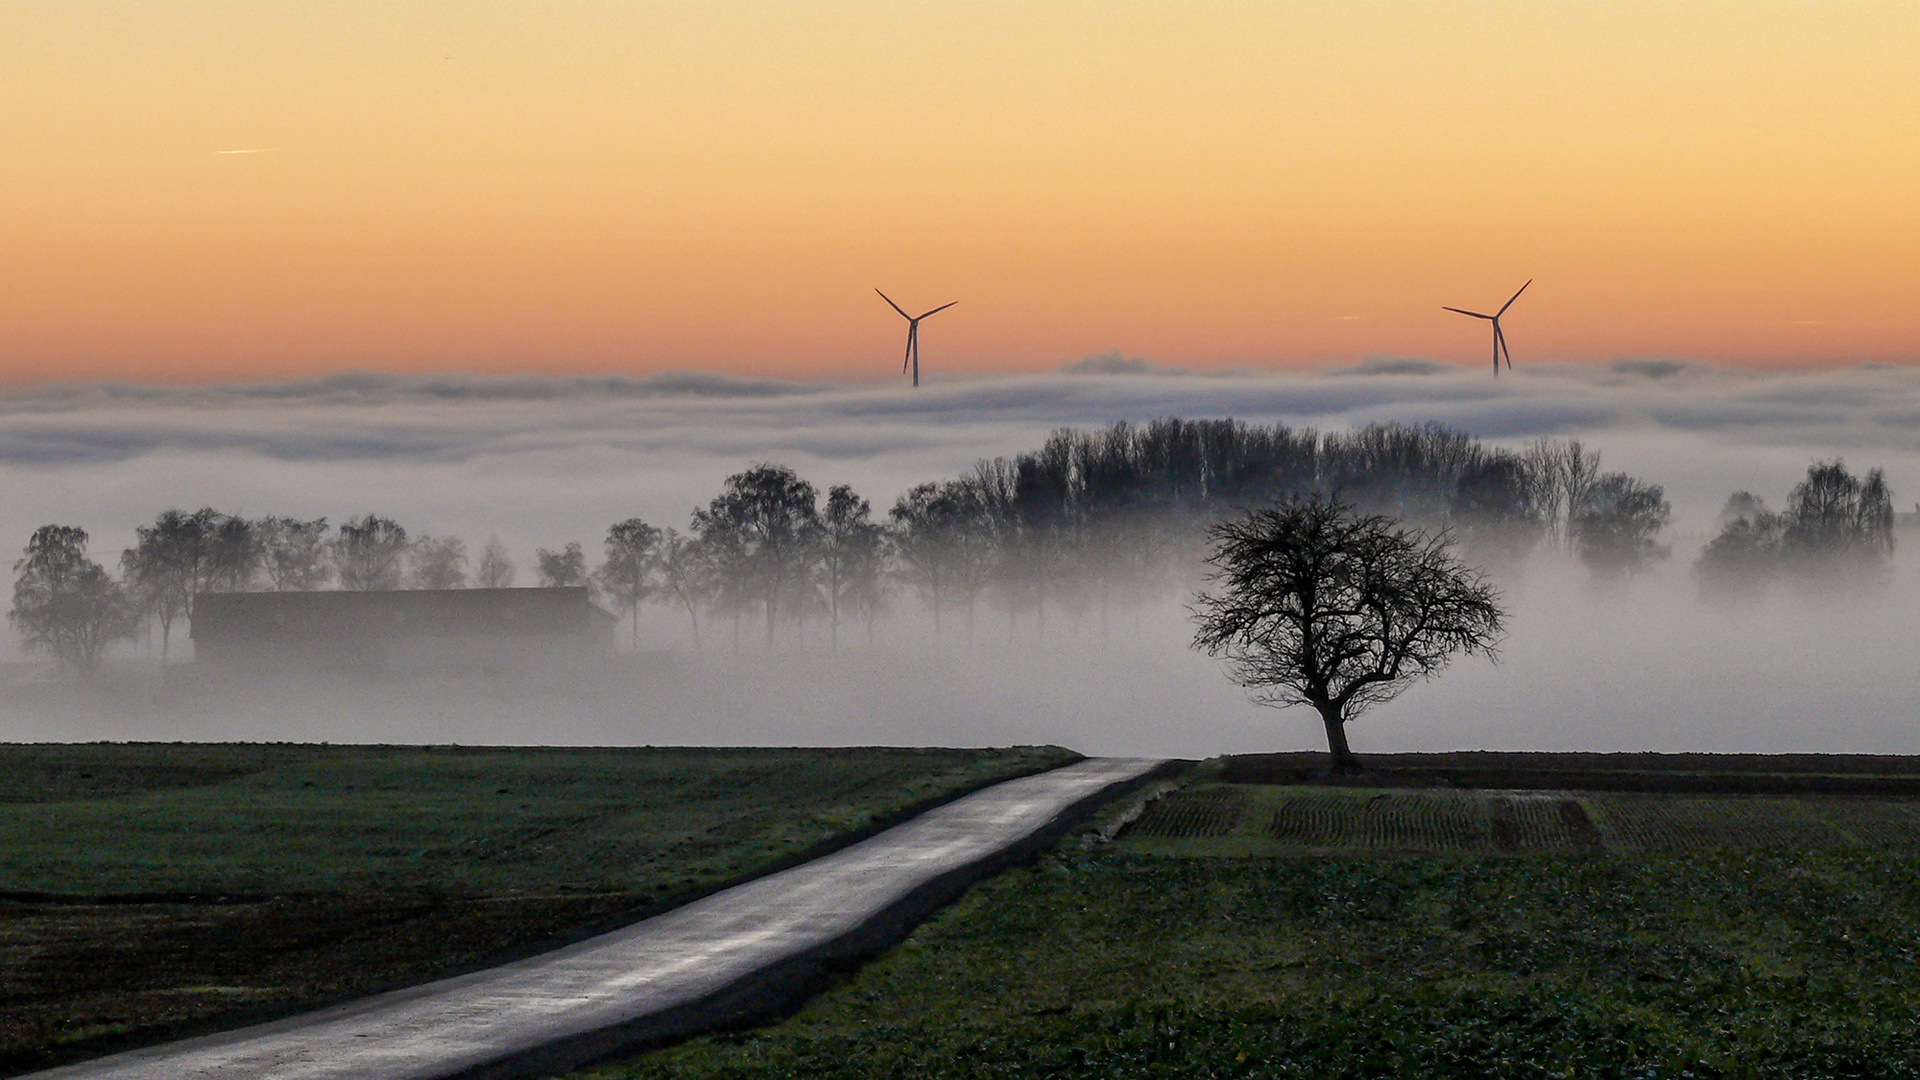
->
0;744;1073;1072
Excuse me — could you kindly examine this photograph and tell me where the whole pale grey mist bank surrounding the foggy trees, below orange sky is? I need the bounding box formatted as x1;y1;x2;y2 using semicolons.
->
0;356;1920;757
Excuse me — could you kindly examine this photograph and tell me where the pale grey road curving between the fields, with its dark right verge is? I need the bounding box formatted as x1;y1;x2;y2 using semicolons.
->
31;757;1160;1080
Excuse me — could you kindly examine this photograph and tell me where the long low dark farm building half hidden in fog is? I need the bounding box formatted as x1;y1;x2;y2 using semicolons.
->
190;588;618;673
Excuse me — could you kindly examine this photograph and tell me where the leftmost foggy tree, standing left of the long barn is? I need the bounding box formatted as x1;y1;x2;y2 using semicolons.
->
8;525;138;676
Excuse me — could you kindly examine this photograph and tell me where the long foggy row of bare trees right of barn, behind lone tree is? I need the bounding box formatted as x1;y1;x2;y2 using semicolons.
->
601;419;1670;642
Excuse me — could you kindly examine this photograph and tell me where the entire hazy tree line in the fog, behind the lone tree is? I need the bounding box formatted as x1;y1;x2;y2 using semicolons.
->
10;419;1893;671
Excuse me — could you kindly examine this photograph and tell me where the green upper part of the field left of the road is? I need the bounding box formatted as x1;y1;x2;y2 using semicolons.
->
0;746;1069;896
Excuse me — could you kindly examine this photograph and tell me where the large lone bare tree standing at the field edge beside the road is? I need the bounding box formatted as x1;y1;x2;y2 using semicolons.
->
1194;498;1503;771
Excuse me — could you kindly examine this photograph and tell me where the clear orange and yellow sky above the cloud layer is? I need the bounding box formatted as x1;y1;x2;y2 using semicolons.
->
0;0;1920;380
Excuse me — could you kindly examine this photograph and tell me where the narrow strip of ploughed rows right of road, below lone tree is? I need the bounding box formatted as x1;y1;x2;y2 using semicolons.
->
1123;784;1920;855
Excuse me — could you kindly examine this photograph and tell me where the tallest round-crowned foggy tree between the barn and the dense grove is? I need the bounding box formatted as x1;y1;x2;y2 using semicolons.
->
693;465;820;646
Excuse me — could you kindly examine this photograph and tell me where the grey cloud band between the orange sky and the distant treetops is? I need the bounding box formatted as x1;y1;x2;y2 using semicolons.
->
0;354;1920;546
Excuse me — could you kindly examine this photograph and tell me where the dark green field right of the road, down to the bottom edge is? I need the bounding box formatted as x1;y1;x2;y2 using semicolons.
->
582;760;1920;1080
